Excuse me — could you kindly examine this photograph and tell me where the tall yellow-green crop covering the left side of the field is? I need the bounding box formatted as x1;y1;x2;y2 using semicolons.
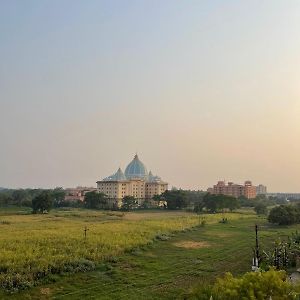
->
0;210;252;285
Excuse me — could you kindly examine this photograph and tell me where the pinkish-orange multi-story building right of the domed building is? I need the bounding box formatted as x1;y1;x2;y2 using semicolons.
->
207;181;256;199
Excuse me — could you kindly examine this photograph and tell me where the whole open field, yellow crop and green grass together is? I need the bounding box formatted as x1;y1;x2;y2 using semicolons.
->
0;210;296;299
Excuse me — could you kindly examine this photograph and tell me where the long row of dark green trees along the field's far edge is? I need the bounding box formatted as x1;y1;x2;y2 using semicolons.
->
0;187;300;225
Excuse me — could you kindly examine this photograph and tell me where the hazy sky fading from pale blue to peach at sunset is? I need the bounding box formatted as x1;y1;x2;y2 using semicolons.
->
0;0;300;192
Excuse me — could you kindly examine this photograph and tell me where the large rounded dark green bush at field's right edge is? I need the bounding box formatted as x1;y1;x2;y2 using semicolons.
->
268;205;299;225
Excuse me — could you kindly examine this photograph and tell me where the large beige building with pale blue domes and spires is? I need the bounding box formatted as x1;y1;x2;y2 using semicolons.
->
97;155;168;207
